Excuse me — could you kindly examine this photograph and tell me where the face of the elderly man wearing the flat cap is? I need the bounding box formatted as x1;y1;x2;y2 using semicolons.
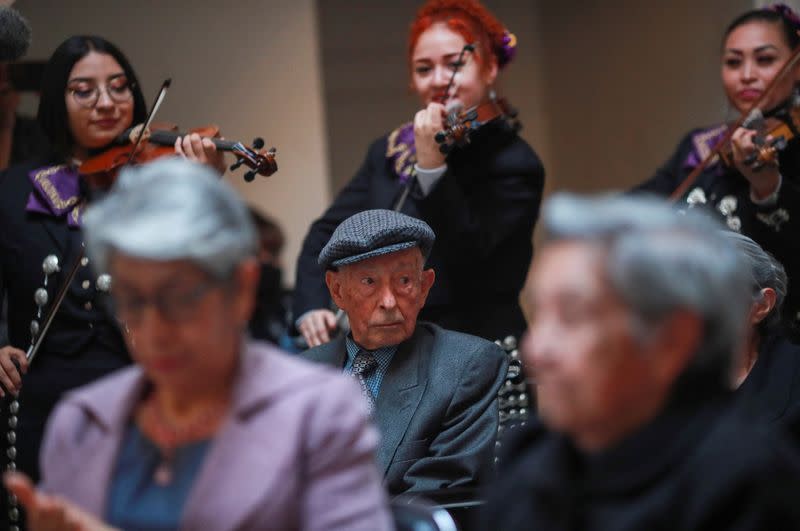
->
325;247;435;350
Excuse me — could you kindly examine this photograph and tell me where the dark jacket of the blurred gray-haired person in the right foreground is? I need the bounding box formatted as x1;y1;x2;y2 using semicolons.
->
480;394;800;531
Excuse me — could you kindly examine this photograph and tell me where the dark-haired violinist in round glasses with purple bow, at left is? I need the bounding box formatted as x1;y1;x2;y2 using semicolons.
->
0;36;224;525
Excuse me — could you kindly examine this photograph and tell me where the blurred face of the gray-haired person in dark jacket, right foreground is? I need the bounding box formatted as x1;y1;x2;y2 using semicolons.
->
520;242;688;450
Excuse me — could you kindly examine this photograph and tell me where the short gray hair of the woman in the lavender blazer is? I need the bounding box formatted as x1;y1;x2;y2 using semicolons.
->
83;157;257;280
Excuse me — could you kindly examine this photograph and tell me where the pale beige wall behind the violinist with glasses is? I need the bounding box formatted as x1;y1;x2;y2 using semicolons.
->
14;0;329;281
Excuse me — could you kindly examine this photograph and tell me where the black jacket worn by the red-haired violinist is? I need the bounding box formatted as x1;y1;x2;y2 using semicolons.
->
292;121;544;340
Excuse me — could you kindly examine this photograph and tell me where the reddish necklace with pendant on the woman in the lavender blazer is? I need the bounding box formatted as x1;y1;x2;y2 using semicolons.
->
137;394;226;487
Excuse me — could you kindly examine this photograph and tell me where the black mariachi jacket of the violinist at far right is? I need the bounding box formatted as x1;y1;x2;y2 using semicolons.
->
634;128;800;336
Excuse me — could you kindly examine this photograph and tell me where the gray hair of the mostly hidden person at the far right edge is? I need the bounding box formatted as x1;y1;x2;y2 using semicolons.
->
724;231;789;335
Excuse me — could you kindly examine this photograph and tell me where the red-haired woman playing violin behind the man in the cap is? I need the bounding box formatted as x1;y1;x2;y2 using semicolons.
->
292;0;544;347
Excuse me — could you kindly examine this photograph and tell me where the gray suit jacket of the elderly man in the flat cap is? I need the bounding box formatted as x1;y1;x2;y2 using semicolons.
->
303;323;508;495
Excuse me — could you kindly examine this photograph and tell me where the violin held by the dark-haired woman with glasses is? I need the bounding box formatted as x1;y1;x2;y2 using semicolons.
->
78;124;278;188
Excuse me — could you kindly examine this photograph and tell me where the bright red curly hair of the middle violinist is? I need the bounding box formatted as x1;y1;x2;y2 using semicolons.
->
408;0;506;74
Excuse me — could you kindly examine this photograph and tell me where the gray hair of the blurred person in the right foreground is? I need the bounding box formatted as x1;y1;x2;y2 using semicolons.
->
543;194;752;385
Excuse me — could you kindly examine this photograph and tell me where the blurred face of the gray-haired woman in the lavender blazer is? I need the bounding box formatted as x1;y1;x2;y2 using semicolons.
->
110;254;258;392
